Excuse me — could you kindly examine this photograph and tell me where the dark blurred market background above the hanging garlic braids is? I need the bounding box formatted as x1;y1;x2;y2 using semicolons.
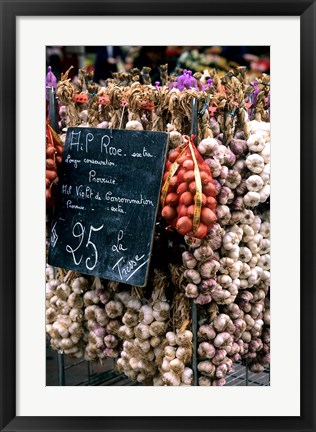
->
46;45;270;85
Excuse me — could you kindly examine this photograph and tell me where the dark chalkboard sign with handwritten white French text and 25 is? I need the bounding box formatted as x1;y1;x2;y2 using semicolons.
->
48;128;168;286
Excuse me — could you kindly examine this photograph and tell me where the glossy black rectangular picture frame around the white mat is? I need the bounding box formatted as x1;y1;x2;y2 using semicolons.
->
0;0;316;432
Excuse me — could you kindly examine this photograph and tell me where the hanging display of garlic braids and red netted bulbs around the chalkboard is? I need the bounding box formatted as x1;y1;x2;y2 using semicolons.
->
46;65;270;386
